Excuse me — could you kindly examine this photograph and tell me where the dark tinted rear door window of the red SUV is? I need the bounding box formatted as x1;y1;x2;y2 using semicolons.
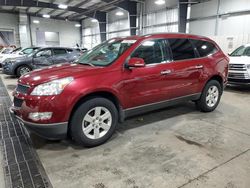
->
168;39;195;61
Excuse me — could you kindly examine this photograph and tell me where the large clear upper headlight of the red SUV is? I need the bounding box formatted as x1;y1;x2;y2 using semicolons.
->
31;77;74;96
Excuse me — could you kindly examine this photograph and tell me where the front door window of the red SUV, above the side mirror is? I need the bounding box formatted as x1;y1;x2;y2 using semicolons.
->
131;40;166;64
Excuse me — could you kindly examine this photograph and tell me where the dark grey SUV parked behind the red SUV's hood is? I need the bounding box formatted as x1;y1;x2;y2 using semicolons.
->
3;47;80;77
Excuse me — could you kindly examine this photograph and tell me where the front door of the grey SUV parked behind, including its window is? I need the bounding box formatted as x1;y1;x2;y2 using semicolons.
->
33;48;53;68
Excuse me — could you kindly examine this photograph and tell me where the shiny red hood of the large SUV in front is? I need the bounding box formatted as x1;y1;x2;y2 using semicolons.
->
18;63;104;86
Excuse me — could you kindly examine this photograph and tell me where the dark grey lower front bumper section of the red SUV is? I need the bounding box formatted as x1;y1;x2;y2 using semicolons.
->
10;107;68;140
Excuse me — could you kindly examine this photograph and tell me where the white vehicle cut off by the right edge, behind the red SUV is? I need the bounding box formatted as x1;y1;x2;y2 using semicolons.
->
228;44;250;85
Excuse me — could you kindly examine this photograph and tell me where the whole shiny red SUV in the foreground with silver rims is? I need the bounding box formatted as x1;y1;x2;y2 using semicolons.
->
11;33;229;147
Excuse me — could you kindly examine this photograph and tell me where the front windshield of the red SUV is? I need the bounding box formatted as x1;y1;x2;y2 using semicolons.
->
76;39;136;66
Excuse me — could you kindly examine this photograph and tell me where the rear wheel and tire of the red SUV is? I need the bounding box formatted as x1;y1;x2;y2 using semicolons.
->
196;80;222;112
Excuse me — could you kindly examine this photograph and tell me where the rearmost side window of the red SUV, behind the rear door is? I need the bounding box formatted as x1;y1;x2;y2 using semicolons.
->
191;39;218;57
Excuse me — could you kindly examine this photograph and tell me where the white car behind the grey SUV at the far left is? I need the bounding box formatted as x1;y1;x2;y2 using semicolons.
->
0;47;39;66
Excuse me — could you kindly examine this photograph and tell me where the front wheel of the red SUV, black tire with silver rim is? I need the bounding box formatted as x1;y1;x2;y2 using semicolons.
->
70;97;118;147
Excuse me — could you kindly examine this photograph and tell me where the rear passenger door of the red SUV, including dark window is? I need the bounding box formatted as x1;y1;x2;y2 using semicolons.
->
161;38;203;98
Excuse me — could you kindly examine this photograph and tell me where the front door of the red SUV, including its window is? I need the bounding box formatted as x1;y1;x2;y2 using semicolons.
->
122;39;171;108
